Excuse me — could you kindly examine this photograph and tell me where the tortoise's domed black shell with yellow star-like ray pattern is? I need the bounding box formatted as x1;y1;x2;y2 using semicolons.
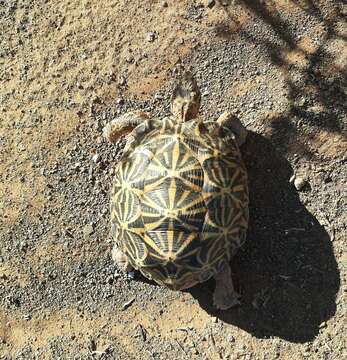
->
111;119;248;289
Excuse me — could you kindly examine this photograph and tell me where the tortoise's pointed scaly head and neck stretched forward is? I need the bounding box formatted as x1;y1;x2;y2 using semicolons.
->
171;72;201;121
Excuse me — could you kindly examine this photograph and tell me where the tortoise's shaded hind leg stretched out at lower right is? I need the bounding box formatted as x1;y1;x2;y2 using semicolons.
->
213;264;241;310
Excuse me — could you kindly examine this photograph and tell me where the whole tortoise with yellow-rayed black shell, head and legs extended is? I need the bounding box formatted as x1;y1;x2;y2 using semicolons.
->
104;72;248;310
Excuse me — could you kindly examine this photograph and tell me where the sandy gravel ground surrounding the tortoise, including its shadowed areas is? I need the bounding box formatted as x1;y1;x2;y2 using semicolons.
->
0;0;347;360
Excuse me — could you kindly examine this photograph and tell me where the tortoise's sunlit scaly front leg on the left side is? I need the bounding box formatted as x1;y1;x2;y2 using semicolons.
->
103;111;148;144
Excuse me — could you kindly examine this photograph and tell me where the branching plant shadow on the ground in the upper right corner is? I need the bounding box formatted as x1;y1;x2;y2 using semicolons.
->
215;0;347;155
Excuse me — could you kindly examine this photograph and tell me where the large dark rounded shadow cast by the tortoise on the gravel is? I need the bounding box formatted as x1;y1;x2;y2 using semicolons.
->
189;132;340;342
